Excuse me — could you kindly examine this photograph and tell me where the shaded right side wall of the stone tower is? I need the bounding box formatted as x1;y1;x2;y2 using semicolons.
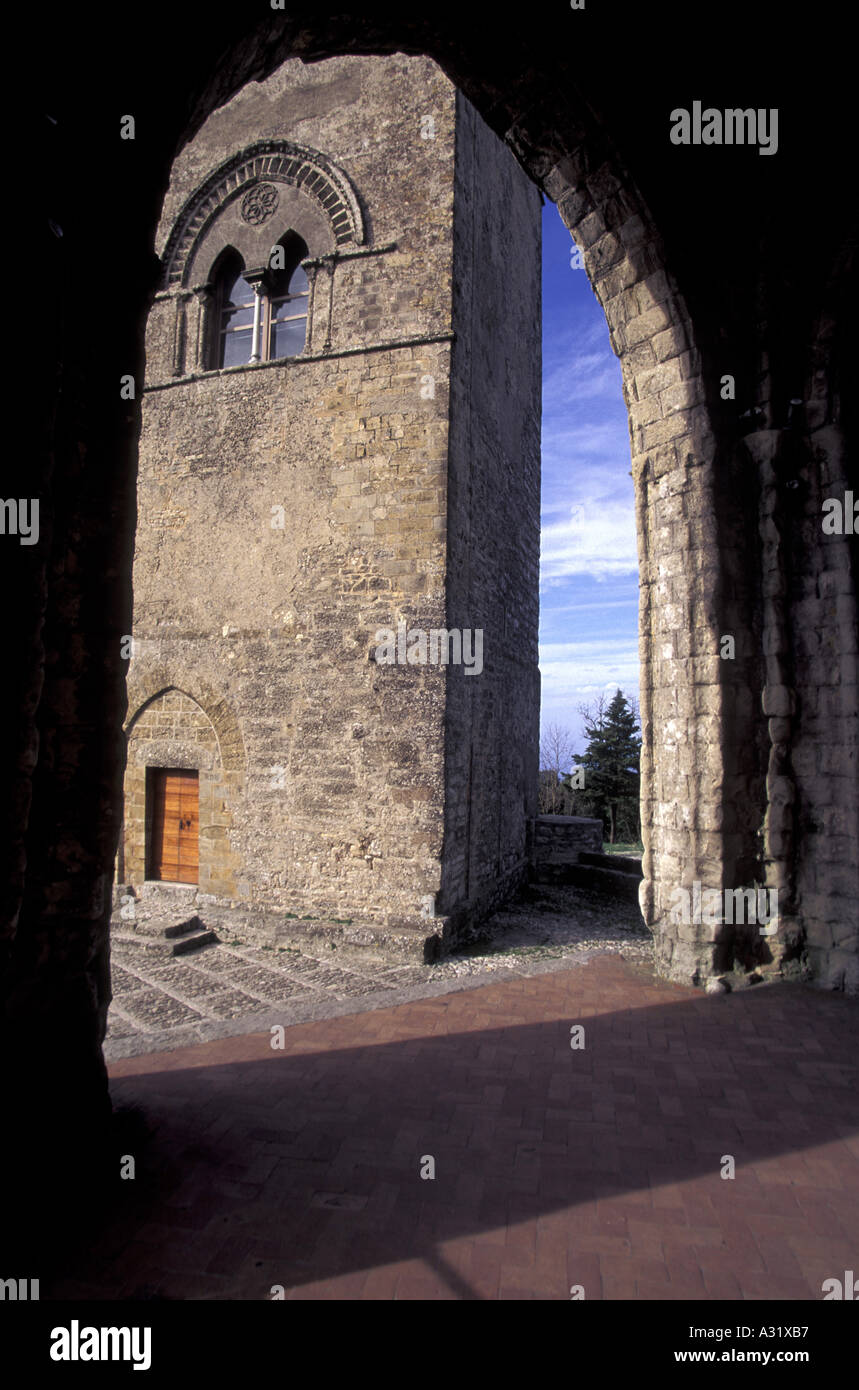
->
439;96;541;917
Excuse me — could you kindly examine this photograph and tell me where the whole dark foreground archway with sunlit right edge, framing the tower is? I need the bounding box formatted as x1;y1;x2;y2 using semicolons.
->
4;3;856;1206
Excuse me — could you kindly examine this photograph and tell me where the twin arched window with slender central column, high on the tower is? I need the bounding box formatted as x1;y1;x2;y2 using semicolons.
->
210;232;310;367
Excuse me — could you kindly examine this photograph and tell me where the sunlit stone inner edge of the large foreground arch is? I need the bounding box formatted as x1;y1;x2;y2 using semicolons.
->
122;24;822;1000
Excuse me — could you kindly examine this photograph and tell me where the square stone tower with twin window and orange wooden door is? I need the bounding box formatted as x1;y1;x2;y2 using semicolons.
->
118;54;541;955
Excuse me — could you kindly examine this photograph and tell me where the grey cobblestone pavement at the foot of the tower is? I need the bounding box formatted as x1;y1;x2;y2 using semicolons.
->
104;887;644;1061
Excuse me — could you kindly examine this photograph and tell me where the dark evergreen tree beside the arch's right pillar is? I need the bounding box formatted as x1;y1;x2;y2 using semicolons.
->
578;691;641;844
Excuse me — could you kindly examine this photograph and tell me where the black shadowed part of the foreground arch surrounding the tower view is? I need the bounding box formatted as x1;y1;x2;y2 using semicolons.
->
10;8;855;1262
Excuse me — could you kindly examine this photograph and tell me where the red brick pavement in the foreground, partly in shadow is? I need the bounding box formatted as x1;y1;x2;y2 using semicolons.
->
43;956;859;1300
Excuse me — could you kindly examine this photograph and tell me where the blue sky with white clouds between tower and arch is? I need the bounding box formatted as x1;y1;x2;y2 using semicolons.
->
539;203;638;752
